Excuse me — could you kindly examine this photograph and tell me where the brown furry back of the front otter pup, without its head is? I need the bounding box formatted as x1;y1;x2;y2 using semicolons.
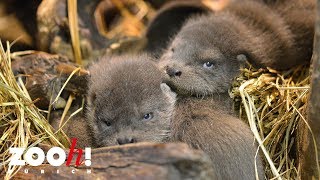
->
171;95;264;179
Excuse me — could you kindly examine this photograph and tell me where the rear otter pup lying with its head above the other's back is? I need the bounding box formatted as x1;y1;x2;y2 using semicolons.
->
160;1;314;95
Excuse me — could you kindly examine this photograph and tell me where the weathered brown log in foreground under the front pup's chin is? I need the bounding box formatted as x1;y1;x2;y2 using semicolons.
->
9;143;215;180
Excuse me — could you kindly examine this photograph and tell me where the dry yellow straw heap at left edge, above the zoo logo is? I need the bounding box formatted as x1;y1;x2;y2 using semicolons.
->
0;42;69;179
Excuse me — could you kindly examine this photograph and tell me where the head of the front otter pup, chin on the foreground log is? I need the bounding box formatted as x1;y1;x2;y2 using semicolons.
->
87;55;175;147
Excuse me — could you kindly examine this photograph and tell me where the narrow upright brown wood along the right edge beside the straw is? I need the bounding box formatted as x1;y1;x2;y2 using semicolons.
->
297;0;320;179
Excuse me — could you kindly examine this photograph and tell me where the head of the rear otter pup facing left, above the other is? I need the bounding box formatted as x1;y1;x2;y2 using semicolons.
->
159;16;247;96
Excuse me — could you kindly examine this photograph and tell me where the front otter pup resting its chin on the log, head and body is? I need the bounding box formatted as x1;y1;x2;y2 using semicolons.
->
88;56;263;179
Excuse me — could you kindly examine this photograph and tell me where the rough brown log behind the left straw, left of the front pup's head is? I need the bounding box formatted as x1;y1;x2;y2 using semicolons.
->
12;52;89;109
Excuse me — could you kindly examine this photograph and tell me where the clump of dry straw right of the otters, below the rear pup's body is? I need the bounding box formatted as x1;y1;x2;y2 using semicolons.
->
230;63;309;179
